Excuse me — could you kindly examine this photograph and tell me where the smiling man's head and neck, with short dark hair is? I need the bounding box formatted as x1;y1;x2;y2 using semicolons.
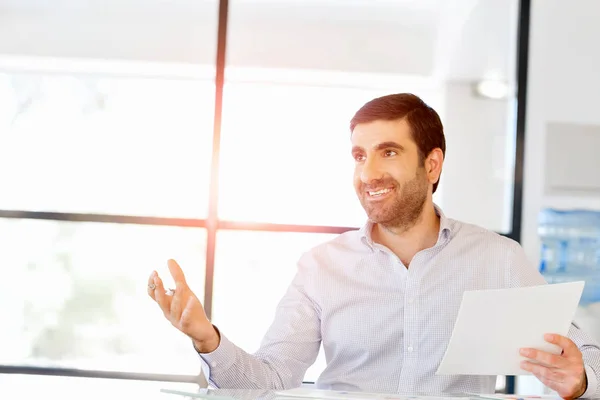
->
350;112;446;268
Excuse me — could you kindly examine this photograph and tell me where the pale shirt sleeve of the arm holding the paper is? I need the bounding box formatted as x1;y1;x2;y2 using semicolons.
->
508;242;600;398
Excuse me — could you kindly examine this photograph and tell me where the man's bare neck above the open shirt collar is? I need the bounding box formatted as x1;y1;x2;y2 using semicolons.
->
371;201;440;268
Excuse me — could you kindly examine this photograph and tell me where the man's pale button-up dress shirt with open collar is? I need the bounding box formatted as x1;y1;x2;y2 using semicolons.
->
200;207;600;397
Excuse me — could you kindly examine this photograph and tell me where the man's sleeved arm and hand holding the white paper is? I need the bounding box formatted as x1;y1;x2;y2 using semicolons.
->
507;242;600;398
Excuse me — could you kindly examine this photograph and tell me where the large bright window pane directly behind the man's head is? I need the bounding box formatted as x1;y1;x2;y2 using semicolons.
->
220;0;519;232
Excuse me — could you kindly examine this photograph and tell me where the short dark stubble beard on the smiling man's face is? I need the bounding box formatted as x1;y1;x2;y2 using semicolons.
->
358;168;429;231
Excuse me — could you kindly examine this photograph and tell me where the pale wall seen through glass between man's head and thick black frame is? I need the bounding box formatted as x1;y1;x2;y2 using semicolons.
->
428;0;519;232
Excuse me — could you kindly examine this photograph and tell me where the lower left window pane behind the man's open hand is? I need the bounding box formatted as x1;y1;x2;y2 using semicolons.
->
0;219;206;374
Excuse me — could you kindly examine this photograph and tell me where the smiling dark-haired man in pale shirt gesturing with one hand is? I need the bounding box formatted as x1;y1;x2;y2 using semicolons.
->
148;94;600;399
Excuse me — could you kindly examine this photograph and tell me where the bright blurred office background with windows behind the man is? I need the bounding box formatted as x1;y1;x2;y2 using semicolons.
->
0;0;600;398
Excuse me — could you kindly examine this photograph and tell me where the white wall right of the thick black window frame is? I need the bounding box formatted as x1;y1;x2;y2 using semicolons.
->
517;0;600;393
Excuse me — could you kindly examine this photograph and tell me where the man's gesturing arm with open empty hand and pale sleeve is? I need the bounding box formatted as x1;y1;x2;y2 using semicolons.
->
148;257;321;389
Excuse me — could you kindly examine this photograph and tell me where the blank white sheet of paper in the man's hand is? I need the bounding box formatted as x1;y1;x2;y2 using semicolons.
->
436;281;584;375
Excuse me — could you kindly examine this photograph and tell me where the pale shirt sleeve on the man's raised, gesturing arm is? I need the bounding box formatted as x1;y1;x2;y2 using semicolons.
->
199;253;321;390
